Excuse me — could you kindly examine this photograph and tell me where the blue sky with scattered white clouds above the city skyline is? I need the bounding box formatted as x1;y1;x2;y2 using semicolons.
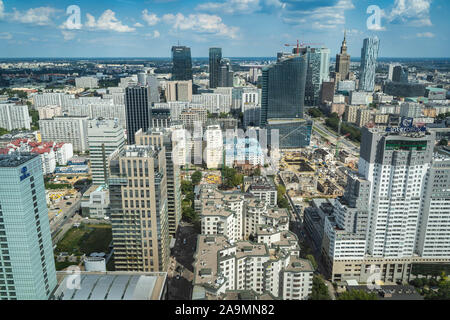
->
0;0;450;57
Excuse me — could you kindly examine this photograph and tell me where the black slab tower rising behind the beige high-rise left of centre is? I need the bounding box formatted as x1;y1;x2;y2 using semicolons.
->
125;86;152;145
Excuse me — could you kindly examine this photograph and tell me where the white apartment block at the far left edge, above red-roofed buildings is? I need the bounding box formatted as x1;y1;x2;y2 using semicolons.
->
0;103;31;131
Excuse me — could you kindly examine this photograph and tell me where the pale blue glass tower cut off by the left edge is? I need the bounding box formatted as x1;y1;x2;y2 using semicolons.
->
0;153;57;300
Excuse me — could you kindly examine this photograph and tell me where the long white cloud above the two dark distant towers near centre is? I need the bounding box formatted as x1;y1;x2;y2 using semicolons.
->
162;13;239;39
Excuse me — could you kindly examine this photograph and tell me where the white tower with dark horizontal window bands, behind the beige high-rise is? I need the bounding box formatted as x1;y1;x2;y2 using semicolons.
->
88;118;125;185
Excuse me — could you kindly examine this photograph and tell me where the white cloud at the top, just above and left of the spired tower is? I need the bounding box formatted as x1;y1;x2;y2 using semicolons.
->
283;0;355;29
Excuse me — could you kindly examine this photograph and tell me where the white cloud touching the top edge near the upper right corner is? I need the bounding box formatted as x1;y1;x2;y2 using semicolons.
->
386;0;433;26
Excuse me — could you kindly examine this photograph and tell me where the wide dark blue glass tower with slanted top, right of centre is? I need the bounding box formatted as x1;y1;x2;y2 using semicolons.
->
260;54;308;126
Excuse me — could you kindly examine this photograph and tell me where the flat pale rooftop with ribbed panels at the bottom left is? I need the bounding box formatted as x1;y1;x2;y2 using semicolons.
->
53;272;167;300
